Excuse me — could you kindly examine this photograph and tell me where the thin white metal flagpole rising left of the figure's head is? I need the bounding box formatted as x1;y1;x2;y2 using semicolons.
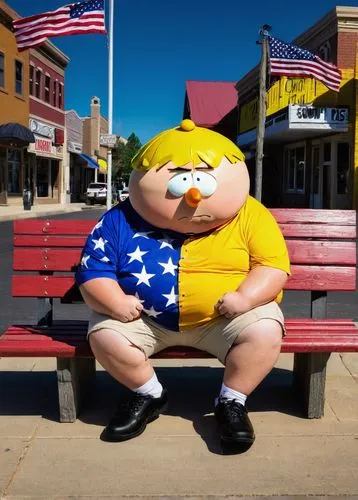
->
107;0;114;210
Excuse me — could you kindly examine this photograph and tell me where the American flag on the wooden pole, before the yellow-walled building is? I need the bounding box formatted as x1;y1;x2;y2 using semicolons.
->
268;36;342;92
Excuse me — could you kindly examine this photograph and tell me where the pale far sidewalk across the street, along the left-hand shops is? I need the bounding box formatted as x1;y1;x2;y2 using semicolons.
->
0;203;106;222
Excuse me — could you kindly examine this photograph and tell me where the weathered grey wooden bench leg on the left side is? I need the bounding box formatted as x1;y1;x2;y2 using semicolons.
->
57;358;96;422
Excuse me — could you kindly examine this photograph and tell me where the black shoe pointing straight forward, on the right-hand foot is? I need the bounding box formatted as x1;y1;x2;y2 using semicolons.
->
215;398;255;444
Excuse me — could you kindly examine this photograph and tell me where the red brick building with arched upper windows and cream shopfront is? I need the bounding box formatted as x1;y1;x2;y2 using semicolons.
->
28;42;69;204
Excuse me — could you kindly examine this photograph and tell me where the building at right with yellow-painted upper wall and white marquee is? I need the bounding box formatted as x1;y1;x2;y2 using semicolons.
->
236;7;358;209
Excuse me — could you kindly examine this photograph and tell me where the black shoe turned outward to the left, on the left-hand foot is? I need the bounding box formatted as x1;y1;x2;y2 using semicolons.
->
101;389;168;441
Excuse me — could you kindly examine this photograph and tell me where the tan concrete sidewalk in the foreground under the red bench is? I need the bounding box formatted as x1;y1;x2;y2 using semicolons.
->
0;354;358;500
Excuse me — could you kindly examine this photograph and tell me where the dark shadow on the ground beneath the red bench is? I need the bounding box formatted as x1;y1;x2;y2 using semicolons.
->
0;367;304;454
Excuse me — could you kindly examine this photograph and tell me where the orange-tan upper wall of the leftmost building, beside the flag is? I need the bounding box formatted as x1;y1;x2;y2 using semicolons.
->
0;18;29;127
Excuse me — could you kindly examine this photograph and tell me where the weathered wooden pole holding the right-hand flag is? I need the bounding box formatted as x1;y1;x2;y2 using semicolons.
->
255;24;271;201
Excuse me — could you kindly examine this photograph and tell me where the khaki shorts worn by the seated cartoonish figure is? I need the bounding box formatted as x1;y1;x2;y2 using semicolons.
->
88;302;285;364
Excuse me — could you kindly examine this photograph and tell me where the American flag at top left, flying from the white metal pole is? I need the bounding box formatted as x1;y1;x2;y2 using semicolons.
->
13;0;106;51
